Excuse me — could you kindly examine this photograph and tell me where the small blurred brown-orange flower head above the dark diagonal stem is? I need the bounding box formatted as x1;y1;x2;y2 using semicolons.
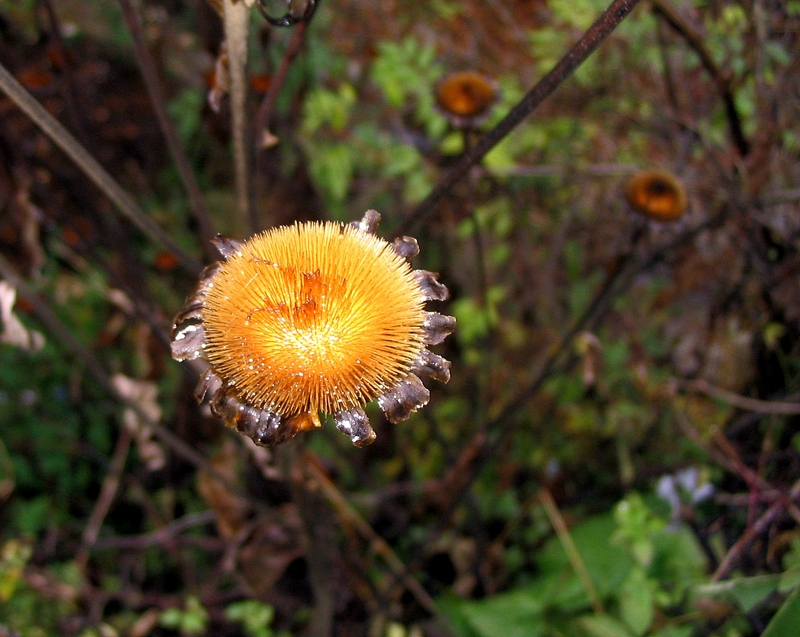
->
436;71;497;127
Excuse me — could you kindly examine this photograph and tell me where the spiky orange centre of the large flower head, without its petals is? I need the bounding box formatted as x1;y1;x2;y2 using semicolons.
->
203;222;425;416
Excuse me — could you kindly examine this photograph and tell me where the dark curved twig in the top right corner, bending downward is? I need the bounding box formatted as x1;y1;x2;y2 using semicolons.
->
651;0;750;157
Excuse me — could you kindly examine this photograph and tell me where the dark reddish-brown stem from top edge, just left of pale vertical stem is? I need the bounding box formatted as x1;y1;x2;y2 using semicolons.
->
119;0;217;261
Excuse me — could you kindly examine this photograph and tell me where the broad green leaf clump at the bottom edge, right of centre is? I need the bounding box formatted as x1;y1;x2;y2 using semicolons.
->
443;493;705;637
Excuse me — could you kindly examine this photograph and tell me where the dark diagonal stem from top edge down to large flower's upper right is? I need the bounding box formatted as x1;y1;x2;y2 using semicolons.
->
394;0;639;236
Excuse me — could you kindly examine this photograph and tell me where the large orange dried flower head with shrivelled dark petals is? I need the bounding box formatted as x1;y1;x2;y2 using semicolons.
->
172;210;455;446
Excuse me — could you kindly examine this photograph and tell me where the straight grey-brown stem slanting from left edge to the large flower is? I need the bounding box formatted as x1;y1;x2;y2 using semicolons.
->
0;64;201;275
